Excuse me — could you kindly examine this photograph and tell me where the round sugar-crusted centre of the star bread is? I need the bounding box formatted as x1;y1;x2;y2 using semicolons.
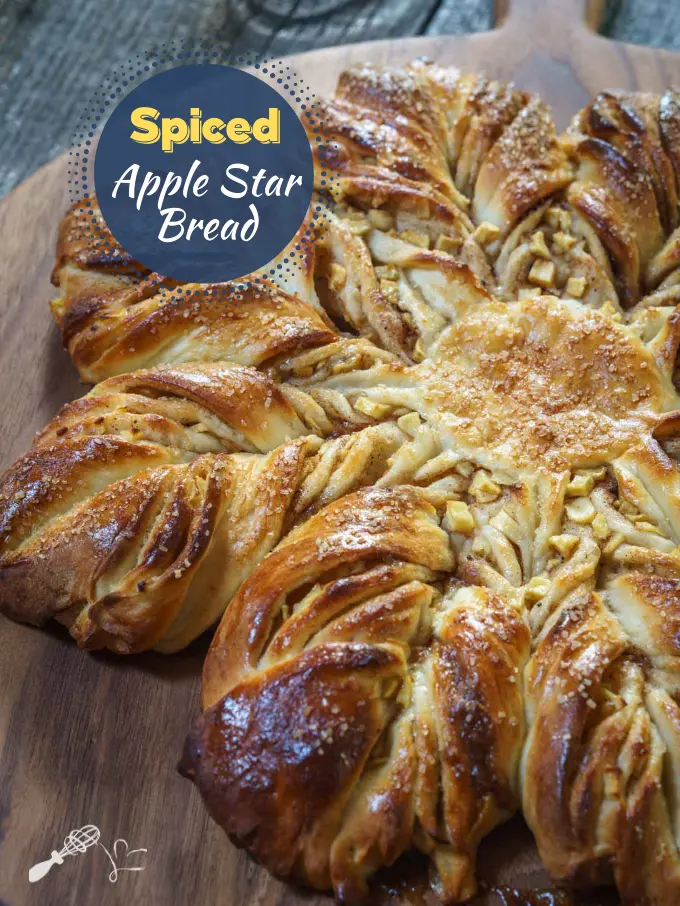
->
419;297;671;469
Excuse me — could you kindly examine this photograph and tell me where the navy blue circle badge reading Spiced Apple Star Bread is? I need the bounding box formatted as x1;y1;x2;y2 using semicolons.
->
94;65;314;283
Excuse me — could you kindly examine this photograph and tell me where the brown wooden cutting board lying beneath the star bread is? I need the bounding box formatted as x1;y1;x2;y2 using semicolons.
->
0;0;680;906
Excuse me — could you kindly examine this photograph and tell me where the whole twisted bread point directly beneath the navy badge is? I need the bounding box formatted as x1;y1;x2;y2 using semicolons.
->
47;199;337;382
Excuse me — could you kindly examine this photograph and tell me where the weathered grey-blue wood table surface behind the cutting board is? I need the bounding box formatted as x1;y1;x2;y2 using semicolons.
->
0;0;680;197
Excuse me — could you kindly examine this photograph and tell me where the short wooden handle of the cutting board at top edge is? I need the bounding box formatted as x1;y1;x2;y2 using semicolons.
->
494;0;605;37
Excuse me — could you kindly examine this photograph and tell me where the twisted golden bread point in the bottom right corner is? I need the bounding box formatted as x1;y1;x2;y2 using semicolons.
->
522;576;680;904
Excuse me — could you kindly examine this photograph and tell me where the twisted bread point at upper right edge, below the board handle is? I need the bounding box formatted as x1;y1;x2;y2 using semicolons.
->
495;91;680;314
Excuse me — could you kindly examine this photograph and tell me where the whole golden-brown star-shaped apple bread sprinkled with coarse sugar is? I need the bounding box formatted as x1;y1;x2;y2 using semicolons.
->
0;63;680;906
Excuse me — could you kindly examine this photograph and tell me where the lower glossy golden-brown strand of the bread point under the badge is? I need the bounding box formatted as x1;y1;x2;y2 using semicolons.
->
53;268;337;382
